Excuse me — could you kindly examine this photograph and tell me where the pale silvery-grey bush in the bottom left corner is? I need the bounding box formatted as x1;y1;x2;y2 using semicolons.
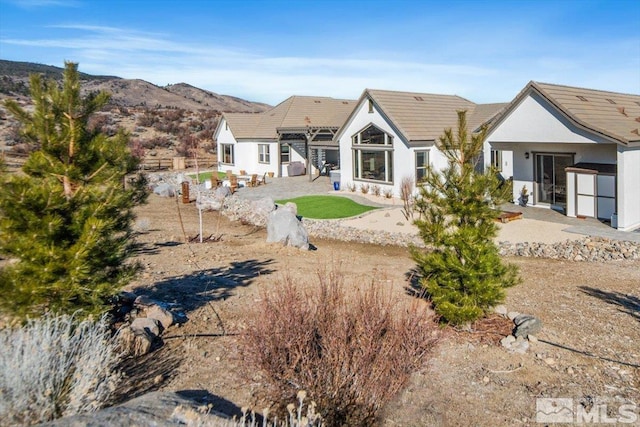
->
0;315;120;425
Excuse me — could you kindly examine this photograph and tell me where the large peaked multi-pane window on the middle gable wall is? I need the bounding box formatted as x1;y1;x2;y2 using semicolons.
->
351;125;393;183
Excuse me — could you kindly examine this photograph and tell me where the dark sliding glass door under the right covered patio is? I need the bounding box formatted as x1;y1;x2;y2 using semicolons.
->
535;154;573;209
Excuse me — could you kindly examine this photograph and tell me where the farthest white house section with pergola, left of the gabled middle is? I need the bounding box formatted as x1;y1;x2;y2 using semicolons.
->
214;96;355;176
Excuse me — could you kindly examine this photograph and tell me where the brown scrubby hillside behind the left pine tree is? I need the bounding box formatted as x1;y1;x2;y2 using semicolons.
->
0;60;271;161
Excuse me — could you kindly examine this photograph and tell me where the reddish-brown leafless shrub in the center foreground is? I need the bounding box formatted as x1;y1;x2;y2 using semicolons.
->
244;268;438;426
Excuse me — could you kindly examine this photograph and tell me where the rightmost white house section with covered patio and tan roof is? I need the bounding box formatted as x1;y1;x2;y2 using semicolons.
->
485;82;640;230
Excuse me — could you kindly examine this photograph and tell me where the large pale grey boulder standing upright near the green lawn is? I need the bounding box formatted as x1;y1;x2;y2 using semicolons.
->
267;203;309;250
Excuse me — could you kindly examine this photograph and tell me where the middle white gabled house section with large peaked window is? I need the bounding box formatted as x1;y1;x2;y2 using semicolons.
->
335;89;506;196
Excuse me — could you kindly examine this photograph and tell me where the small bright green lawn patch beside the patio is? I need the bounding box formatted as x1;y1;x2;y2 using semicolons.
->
276;196;377;219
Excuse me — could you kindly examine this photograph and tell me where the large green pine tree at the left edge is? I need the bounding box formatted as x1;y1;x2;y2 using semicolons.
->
0;62;146;316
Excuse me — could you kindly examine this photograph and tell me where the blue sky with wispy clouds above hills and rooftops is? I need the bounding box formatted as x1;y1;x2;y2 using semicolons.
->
0;0;640;105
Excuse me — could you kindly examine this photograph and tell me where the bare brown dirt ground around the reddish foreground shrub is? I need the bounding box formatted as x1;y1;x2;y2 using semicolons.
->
129;195;640;426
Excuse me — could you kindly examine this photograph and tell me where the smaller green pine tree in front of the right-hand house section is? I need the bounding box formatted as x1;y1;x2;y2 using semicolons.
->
411;111;519;324
